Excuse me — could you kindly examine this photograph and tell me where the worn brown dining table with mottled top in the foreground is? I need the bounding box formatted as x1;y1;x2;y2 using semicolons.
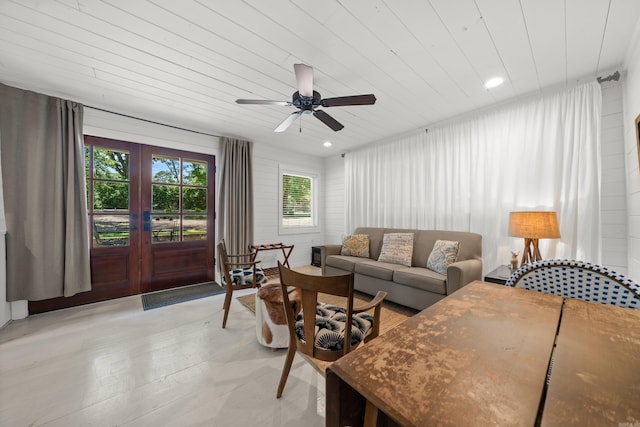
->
326;281;640;427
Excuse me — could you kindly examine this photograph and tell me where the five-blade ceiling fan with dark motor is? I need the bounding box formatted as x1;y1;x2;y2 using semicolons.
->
236;64;376;132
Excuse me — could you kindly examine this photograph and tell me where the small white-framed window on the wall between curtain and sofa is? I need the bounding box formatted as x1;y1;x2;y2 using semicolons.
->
279;165;318;234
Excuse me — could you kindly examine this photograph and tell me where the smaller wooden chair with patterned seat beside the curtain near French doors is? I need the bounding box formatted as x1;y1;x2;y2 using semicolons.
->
218;240;267;328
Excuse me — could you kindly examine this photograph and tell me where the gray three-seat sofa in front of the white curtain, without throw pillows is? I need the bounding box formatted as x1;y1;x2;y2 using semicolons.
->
320;227;482;310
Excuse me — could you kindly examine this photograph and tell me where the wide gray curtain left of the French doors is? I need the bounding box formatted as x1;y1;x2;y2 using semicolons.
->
0;84;91;301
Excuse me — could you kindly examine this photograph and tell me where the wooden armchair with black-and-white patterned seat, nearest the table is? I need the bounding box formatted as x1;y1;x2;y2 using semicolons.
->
277;262;387;398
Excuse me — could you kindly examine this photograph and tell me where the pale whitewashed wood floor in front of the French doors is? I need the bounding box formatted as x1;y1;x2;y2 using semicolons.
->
0;290;325;427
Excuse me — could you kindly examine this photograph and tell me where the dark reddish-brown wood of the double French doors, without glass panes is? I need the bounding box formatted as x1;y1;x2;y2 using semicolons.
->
29;135;215;314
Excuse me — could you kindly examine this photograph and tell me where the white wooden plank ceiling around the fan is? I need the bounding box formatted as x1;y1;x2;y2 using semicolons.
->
0;0;640;156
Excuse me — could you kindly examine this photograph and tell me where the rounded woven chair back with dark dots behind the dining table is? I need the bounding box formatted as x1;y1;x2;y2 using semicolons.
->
505;260;640;310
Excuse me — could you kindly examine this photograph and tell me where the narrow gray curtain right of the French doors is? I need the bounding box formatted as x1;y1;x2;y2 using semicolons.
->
218;138;253;254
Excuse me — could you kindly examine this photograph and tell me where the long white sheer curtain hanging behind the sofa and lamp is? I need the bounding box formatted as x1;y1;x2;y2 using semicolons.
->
345;82;602;272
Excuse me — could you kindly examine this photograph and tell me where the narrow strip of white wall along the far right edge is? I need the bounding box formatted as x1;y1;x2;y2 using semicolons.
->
623;21;640;281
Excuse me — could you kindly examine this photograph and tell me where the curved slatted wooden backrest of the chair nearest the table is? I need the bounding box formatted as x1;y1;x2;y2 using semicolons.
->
278;262;353;361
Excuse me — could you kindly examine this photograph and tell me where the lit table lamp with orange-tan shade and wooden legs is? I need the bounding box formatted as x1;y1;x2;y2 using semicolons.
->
509;211;560;265
